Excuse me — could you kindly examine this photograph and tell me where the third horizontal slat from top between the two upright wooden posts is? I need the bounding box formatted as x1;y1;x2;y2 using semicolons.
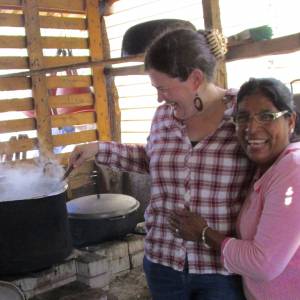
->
41;37;88;49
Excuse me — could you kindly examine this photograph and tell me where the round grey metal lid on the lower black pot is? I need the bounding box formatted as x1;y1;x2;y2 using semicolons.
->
67;194;140;219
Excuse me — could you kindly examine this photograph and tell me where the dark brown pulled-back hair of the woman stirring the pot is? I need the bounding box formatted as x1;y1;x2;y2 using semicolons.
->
144;29;217;81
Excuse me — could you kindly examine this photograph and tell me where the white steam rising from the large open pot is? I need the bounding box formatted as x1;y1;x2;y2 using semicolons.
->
0;161;65;201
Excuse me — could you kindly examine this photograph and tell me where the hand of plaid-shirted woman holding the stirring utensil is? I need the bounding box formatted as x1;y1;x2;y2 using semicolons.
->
69;143;99;168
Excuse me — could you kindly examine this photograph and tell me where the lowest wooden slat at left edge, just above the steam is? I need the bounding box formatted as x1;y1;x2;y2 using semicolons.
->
0;138;38;154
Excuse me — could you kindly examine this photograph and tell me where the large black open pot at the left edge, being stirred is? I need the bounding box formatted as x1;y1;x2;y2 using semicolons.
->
0;188;72;277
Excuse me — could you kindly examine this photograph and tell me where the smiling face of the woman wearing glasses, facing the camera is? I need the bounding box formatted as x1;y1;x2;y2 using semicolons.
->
236;93;295;170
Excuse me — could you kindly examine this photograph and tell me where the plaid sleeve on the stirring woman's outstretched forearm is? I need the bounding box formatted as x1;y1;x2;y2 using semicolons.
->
96;142;149;173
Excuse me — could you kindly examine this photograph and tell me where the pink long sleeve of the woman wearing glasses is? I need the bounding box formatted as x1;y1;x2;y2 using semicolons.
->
222;157;300;281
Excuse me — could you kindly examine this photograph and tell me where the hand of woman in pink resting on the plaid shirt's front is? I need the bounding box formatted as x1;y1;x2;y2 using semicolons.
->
169;209;207;241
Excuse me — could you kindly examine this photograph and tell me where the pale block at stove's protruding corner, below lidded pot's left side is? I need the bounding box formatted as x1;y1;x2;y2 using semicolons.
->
76;252;109;277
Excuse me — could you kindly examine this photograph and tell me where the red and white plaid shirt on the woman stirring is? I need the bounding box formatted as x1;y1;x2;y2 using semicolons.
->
97;92;253;274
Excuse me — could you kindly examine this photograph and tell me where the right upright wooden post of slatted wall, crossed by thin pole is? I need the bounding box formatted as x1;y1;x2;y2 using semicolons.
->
86;0;111;140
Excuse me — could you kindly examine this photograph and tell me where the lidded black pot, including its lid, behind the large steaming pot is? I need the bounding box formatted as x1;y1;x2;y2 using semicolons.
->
67;194;140;247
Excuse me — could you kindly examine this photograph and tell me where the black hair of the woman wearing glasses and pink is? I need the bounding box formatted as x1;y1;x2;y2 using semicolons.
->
237;78;300;135
